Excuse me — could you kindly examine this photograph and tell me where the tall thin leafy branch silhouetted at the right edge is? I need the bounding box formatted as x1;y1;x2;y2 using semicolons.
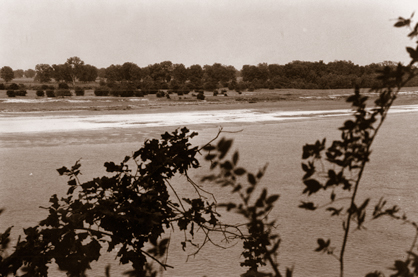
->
299;11;418;277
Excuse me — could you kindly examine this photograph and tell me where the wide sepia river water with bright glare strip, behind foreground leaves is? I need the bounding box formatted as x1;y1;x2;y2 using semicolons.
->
0;106;418;277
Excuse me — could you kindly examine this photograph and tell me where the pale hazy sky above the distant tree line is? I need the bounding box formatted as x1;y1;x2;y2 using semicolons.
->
0;0;418;70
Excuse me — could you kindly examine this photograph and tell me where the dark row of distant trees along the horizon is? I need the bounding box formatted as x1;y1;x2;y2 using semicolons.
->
0;57;418;91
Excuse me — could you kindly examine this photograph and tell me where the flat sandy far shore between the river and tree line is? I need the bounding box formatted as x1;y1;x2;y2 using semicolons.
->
0;88;418;117
